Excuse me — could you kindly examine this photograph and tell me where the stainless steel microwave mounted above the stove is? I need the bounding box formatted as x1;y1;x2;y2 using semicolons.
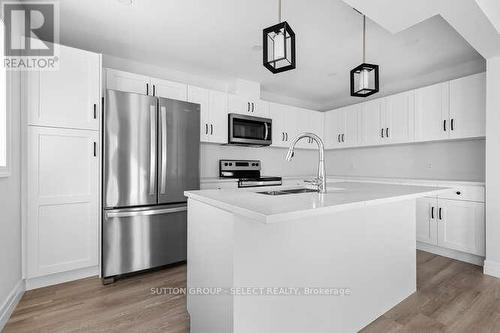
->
228;113;273;147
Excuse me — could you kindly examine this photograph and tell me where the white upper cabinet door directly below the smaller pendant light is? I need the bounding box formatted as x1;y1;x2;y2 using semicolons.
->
361;98;385;146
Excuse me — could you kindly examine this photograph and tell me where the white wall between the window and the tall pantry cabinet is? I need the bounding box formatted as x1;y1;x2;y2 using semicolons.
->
0;72;22;324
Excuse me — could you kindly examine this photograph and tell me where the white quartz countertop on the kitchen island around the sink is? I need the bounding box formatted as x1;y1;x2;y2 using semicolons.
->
184;182;447;223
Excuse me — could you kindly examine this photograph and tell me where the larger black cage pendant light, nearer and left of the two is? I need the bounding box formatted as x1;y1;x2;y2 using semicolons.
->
263;0;295;74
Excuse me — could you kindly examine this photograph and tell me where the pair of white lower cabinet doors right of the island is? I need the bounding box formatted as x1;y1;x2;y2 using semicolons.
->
417;198;485;257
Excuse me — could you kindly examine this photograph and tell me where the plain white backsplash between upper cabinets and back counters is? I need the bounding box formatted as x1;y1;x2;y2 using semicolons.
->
201;139;485;181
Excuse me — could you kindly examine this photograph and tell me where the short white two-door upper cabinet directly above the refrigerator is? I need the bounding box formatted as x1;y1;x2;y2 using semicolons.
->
106;68;187;101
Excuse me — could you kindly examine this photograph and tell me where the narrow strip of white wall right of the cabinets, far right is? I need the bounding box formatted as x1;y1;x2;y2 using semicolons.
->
484;56;500;277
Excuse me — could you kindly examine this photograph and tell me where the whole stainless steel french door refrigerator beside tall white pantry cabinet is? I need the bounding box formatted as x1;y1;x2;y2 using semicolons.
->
102;90;200;283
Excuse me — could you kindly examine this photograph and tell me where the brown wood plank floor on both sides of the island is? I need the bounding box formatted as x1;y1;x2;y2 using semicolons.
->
4;251;500;333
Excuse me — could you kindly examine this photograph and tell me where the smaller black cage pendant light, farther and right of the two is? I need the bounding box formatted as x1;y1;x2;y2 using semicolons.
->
351;15;379;97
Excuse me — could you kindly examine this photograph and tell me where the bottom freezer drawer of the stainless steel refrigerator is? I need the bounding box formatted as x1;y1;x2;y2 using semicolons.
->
102;204;187;278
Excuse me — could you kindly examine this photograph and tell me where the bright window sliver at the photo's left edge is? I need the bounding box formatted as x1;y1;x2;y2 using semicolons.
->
0;20;10;177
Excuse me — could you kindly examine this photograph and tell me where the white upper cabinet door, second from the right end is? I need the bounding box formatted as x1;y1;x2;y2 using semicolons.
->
415;82;450;141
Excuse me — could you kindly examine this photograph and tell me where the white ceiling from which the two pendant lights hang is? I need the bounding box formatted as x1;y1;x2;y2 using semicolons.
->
53;0;485;110
